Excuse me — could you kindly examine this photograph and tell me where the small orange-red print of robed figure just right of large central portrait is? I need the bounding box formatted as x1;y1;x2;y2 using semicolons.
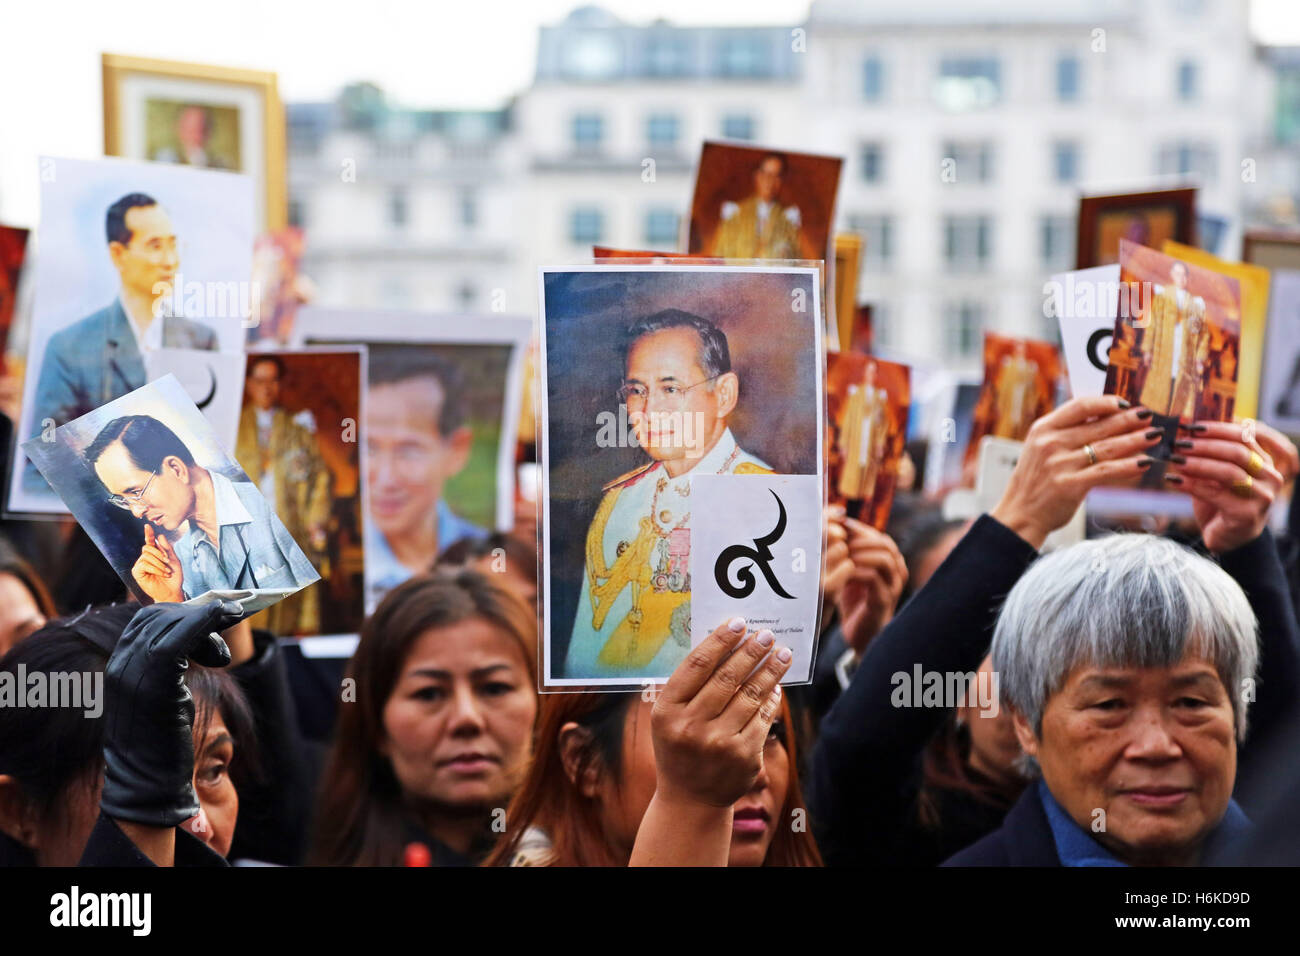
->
826;352;911;531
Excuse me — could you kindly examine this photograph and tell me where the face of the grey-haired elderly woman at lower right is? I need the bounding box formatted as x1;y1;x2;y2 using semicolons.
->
1015;656;1236;865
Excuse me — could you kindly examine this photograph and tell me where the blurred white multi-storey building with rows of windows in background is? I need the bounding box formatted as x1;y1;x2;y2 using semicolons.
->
289;0;1300;364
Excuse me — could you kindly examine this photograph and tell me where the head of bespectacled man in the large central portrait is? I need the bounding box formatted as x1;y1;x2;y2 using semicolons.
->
624;328;738;462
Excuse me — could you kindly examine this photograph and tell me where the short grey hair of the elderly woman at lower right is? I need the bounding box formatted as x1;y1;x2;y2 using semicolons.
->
993;535;1260;740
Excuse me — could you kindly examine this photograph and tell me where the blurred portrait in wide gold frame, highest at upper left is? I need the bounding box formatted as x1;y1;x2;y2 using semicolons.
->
103;53;289;230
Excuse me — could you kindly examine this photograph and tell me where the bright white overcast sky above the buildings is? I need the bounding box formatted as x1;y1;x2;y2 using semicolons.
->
0;0;1300;225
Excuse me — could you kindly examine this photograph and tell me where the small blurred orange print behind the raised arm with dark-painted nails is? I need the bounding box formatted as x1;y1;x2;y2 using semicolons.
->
965;332;1061;476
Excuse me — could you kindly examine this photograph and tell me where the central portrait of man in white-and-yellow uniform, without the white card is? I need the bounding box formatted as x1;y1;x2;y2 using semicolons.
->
541;265;824;687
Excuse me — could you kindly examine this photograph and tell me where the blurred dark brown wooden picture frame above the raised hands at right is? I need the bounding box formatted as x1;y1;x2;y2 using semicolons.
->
1074;187;1197;269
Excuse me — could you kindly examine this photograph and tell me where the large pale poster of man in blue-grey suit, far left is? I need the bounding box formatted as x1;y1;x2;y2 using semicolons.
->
7;157;257;514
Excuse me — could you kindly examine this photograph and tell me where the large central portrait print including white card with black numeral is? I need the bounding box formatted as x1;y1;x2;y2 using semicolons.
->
540;264;824;691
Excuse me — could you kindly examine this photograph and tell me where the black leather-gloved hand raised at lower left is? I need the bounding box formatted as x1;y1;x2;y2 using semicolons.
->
99;601;243;827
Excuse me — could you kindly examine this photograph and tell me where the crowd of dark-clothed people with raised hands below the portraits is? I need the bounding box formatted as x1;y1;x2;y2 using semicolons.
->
0;395;1300;866
